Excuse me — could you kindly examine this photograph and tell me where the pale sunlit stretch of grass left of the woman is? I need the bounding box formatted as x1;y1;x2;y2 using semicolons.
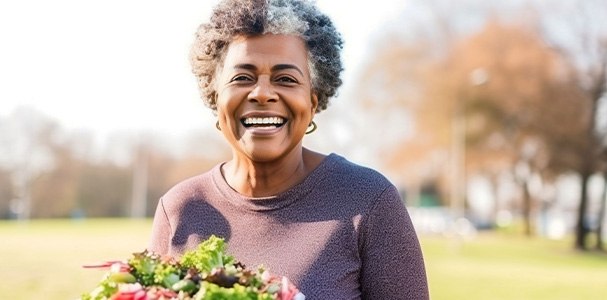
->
0;219;151;300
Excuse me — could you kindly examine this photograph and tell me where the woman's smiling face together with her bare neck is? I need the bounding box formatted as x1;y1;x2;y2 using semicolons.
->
216;34;322;179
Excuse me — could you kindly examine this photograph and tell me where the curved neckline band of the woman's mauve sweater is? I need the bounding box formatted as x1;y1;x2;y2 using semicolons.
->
211;153;339;211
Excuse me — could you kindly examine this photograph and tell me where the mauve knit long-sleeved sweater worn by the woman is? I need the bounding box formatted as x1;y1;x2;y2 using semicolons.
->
149;154;429;300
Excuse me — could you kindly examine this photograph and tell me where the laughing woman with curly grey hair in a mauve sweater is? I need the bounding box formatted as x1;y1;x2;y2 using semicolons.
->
150;0;428;299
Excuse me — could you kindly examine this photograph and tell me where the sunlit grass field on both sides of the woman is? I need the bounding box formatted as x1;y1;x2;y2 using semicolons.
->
0;220;607;300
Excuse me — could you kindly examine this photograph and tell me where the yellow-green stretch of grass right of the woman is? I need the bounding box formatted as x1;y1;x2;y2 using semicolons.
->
421;233;607;300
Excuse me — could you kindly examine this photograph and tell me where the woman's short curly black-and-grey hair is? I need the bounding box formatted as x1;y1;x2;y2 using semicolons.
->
190;0;343;112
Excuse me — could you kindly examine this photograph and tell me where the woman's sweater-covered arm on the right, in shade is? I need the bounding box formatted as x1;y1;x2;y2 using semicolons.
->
360;186;429;299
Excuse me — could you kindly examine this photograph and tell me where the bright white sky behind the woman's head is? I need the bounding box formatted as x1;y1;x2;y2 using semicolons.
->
0;0;406;138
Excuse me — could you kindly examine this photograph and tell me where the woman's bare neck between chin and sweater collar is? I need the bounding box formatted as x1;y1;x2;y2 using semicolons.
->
222;148;320;197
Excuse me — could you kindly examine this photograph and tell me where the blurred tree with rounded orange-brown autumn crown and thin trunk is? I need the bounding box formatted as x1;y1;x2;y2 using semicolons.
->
433;21;583;235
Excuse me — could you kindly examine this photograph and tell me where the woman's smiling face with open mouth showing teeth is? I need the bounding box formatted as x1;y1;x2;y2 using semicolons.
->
217;34;318;162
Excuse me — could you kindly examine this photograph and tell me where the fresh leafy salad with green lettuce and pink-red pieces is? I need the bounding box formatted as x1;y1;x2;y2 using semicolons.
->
80;236;305;300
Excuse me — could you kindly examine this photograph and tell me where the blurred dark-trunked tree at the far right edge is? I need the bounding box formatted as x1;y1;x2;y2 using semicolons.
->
537;0;607;250
